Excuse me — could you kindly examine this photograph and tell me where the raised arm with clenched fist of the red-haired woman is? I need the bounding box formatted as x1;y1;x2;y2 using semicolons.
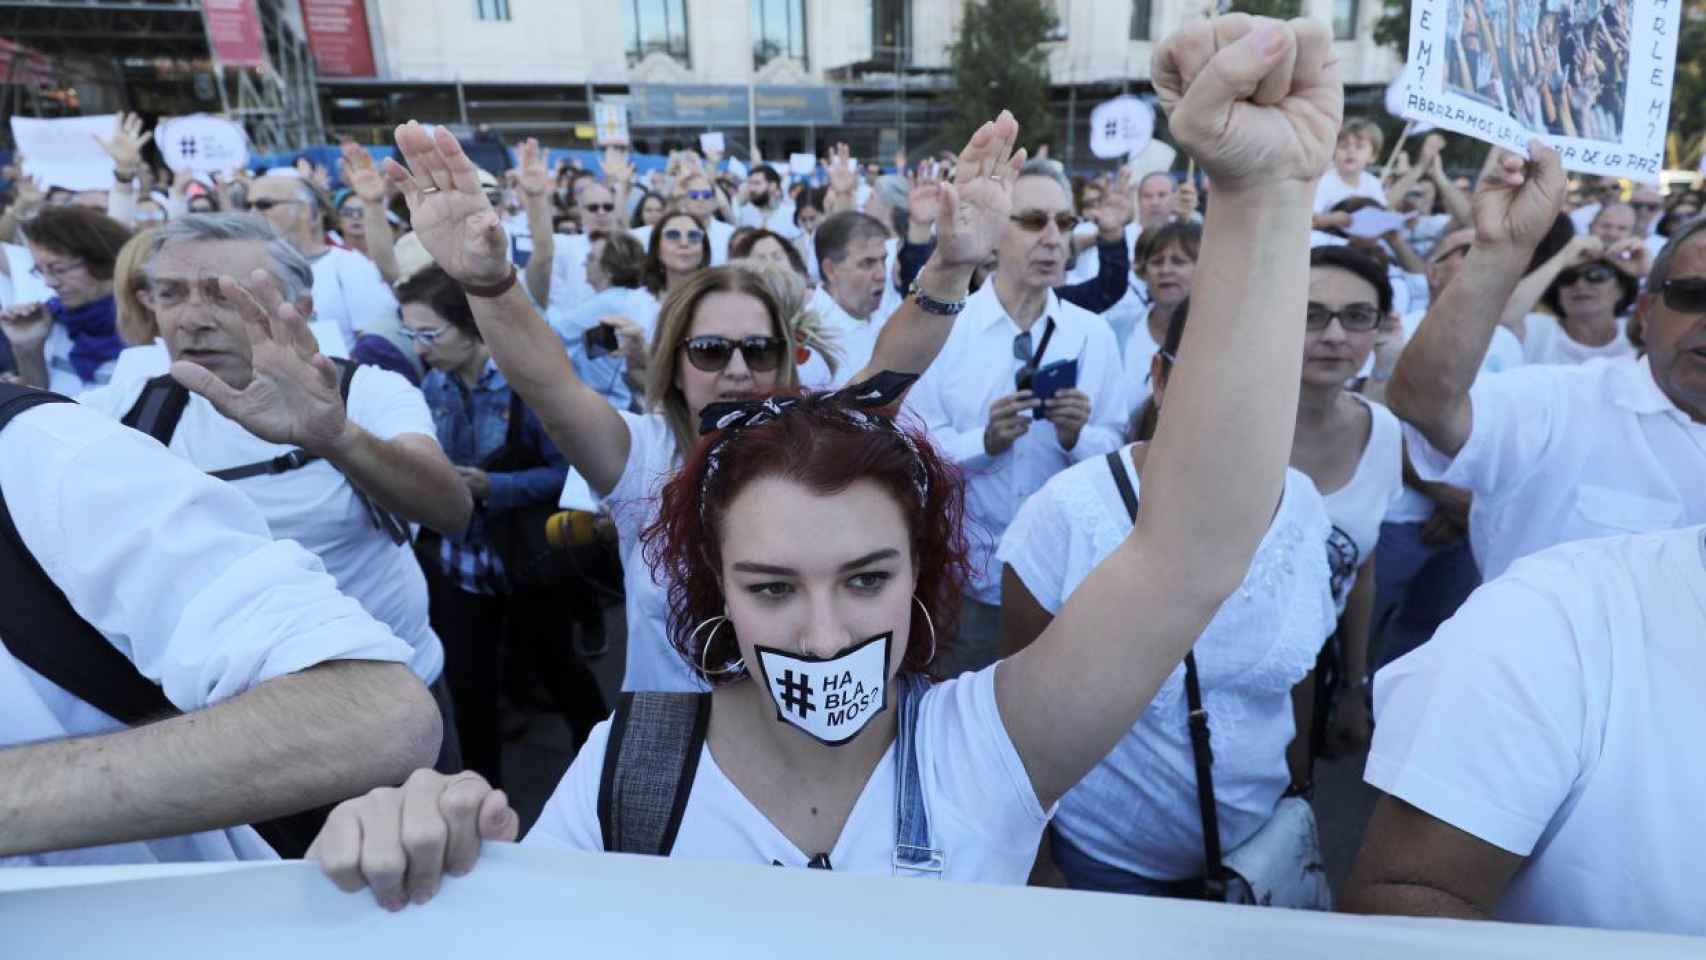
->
995;14;1344;805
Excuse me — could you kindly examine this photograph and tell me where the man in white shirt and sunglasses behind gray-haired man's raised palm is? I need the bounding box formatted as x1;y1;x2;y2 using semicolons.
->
249;171;399;356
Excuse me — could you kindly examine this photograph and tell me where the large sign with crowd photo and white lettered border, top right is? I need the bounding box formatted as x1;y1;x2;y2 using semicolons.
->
1401;0;1682;179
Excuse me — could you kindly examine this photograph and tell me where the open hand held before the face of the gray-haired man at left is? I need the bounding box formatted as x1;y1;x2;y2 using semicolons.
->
172;269;348;457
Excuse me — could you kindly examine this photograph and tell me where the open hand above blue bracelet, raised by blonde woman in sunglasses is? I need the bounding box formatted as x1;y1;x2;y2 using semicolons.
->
933;111;1025;271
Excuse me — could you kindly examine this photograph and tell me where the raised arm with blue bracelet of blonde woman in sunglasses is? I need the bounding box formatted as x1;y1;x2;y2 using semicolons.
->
850;111;1025;384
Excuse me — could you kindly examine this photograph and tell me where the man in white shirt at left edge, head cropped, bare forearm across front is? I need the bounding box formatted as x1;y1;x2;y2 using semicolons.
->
0;387;440;866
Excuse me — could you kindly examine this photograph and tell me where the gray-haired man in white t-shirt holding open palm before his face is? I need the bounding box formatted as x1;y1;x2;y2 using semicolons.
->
80;213;473;770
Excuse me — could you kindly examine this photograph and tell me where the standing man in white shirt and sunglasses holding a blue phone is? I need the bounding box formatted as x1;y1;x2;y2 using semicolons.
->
907;162;1126;675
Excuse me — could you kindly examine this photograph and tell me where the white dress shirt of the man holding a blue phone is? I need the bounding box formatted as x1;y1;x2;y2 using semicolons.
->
906;276;1126;604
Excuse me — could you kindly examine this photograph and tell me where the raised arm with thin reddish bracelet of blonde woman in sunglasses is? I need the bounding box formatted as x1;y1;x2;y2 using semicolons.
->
386;121;631;494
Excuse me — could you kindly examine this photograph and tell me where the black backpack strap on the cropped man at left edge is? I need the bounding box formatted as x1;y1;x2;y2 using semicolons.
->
0;385;179;726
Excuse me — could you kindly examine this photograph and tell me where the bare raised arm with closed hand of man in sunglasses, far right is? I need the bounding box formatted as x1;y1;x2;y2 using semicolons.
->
1387;140;1564;457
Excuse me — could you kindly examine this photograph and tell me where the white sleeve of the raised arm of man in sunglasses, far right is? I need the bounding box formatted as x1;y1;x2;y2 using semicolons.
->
1404;367;1571;496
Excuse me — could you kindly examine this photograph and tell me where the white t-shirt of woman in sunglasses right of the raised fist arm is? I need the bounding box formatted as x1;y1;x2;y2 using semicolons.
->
1322;394;1404;614
